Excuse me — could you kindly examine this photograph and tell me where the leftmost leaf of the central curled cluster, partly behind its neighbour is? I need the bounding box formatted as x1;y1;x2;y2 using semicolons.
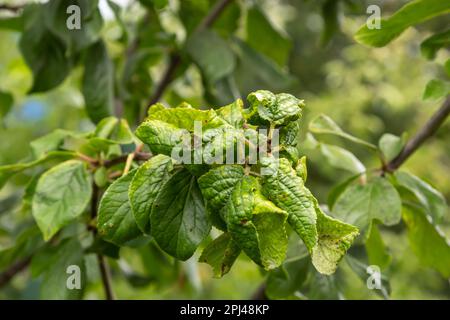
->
97;170;141;246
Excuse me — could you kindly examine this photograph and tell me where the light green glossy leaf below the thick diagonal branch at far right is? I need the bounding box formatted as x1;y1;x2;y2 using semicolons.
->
395;171;448;224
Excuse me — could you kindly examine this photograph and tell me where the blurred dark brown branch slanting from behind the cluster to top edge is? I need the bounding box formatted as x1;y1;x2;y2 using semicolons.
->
147;0;233;114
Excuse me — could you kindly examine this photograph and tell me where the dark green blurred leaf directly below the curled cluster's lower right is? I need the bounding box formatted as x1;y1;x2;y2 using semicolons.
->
266;256;310;299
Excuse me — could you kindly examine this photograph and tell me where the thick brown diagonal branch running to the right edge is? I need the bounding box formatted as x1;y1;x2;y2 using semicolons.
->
383;96;450;172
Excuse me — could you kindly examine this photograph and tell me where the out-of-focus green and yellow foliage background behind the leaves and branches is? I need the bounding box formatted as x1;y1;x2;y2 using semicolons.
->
0;0;450;299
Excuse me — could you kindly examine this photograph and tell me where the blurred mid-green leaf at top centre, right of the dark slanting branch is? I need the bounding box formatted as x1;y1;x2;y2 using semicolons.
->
245;6;291;67
